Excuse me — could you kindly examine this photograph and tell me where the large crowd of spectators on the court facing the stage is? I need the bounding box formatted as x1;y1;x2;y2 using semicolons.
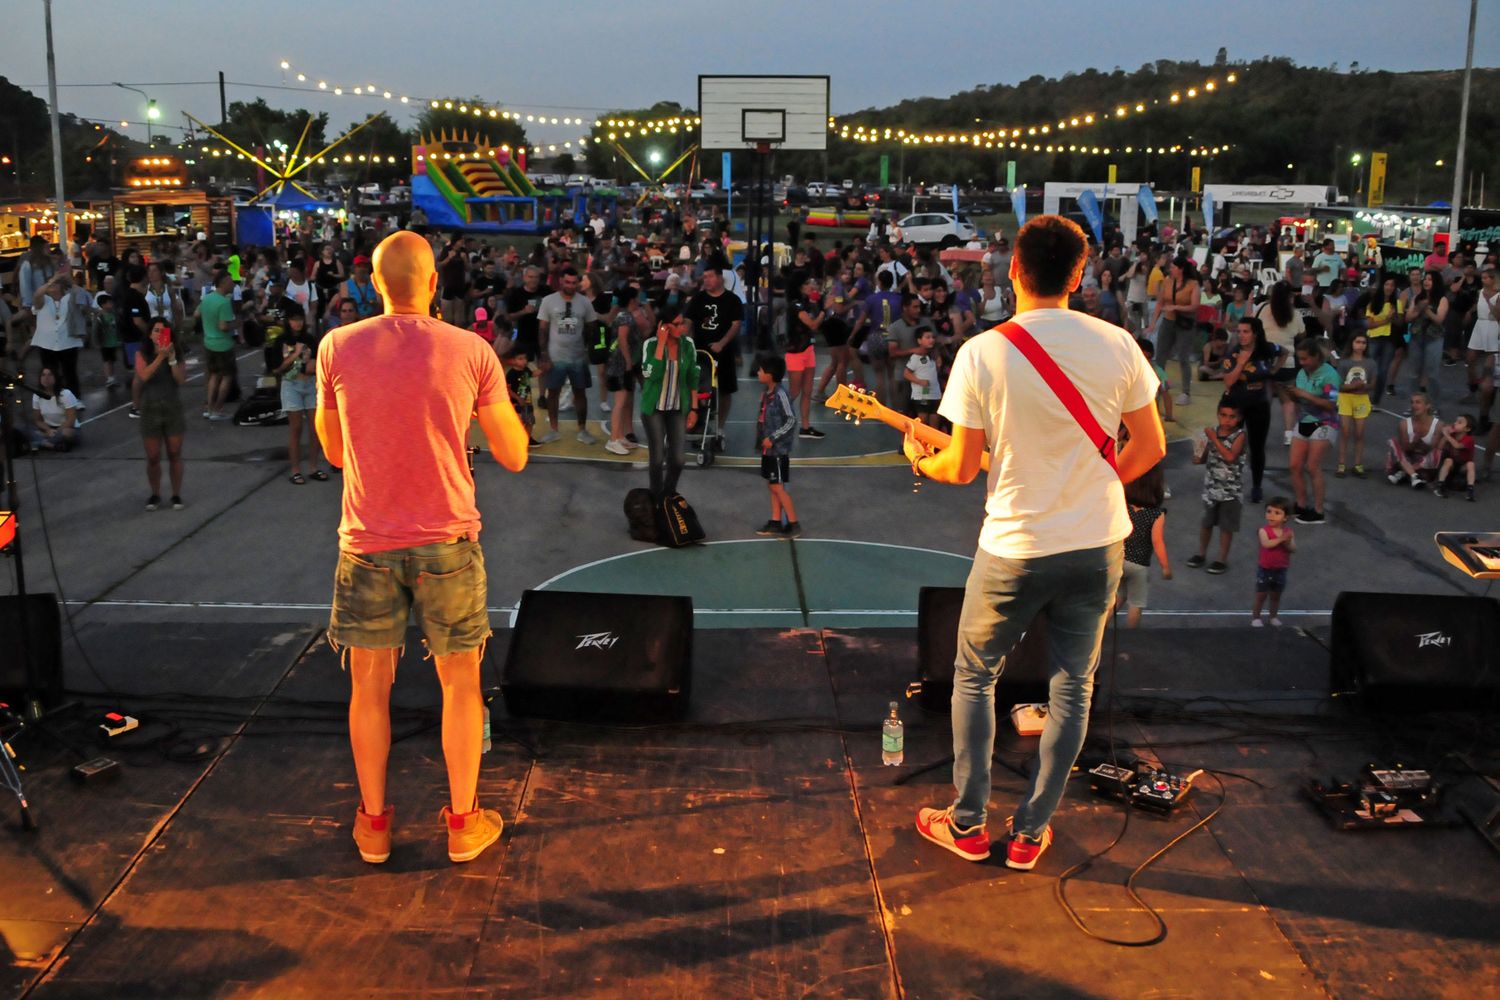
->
0;200;1500;548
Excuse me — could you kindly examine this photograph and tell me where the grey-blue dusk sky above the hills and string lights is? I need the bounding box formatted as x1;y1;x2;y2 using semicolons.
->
0;0;1500;142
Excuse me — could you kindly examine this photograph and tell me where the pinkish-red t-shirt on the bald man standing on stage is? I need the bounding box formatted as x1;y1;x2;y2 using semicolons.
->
318;315;507;552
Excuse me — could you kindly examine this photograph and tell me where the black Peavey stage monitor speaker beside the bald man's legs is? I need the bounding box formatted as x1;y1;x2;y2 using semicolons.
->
501;591;693;723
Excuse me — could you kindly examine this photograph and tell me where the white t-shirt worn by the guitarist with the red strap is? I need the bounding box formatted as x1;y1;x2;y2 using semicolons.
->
938;309;1160;559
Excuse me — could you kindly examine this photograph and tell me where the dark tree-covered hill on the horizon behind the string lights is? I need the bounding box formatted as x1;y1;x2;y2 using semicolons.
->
588;49;1500;204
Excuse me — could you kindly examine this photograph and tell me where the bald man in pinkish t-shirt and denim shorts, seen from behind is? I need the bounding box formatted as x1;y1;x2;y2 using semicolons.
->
317;232;528;864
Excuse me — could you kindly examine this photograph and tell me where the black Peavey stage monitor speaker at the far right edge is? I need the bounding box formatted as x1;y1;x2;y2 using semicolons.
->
1329;591;1500;711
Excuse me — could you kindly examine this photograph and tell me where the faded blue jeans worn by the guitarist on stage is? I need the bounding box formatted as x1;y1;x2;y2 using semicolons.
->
953;544;1125;840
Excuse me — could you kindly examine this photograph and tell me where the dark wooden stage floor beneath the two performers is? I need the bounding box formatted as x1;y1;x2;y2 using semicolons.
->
0;624;1500;1000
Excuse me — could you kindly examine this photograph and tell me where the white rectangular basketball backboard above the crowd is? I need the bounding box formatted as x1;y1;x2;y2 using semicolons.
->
698;76;828;150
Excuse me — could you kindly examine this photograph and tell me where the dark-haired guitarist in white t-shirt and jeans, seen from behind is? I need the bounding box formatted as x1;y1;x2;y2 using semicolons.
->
906;216;1166;870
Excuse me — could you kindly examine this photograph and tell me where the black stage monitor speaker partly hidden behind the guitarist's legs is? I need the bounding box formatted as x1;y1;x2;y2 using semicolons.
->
917;586;1052;715
